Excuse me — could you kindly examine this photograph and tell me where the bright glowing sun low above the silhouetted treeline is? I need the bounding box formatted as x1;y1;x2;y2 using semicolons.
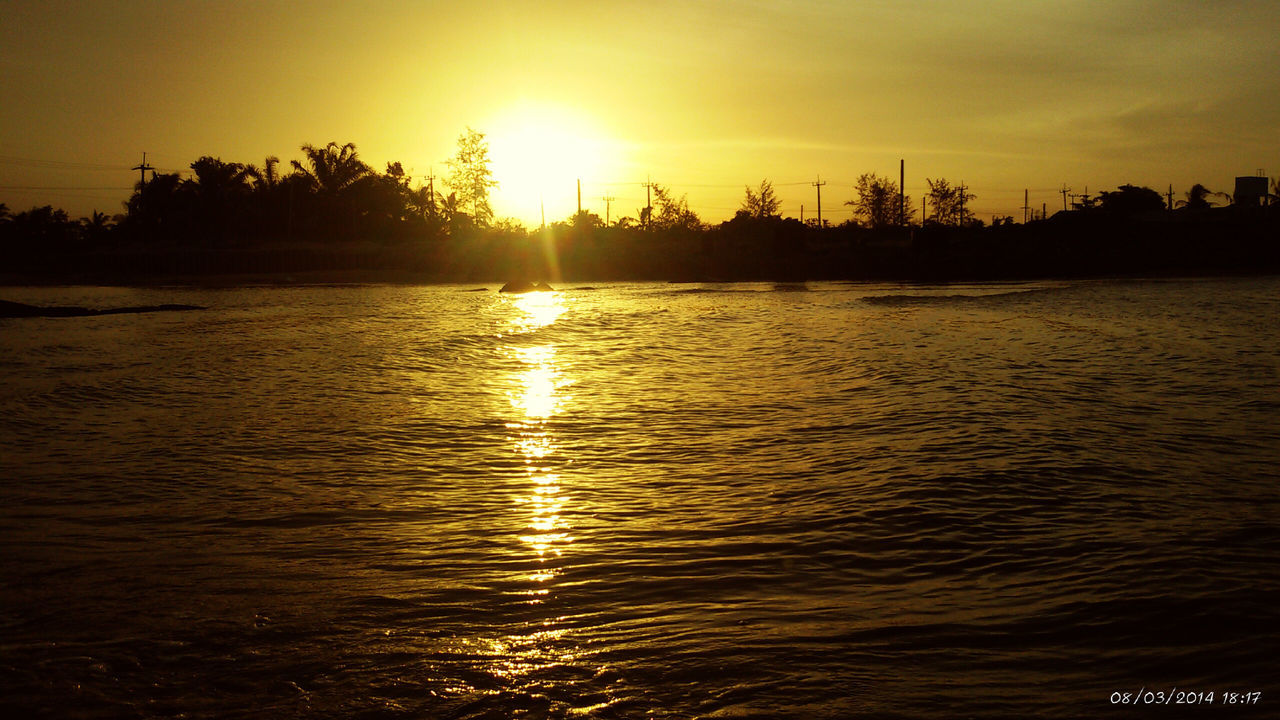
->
485;102;625;228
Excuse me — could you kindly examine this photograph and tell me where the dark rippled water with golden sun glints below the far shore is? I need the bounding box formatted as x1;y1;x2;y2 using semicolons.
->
0;278;1280;719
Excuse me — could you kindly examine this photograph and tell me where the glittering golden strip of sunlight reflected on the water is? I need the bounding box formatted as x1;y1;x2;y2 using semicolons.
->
483;292;575;679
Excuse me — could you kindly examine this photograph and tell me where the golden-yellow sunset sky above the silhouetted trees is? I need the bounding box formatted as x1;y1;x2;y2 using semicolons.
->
0;0;1280;225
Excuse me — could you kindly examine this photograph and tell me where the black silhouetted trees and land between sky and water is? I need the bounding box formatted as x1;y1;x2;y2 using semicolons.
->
0;134;1280;283
